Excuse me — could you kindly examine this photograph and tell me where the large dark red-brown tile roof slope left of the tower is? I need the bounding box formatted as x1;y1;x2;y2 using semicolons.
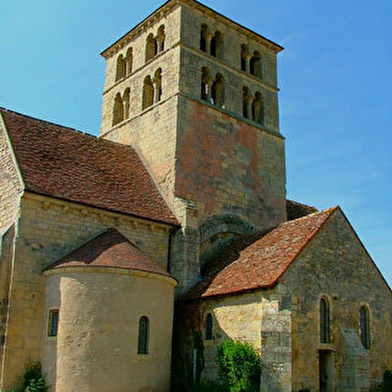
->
0;108;178;225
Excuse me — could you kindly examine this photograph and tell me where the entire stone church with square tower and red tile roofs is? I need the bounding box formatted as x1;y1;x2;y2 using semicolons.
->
0;0;392;392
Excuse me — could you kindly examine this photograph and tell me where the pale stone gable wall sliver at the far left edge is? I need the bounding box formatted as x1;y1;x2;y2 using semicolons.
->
0;114;23;236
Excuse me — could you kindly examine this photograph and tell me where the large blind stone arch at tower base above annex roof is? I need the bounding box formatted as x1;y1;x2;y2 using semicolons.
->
199;214;256;268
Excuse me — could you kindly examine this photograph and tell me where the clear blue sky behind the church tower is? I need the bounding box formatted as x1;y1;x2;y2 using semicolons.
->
0;0;392;285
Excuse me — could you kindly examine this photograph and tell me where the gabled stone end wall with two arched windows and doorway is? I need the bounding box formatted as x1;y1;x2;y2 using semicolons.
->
281;210;392;392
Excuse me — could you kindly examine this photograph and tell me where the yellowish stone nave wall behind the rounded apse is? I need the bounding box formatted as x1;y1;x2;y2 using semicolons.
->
2;193;171;389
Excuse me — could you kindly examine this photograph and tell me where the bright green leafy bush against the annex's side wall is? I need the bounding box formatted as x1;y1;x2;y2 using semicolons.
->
217;339;261;392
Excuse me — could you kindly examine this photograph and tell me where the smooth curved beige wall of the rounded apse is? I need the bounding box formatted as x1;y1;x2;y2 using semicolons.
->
42;268;175;392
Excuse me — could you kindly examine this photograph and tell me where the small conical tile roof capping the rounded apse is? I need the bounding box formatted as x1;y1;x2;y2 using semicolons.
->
45;229;176;277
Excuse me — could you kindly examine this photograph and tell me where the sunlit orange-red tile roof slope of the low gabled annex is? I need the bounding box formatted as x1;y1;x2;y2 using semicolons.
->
185;207;338;299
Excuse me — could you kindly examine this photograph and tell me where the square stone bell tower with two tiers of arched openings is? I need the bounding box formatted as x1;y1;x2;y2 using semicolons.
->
101;0;286;287
